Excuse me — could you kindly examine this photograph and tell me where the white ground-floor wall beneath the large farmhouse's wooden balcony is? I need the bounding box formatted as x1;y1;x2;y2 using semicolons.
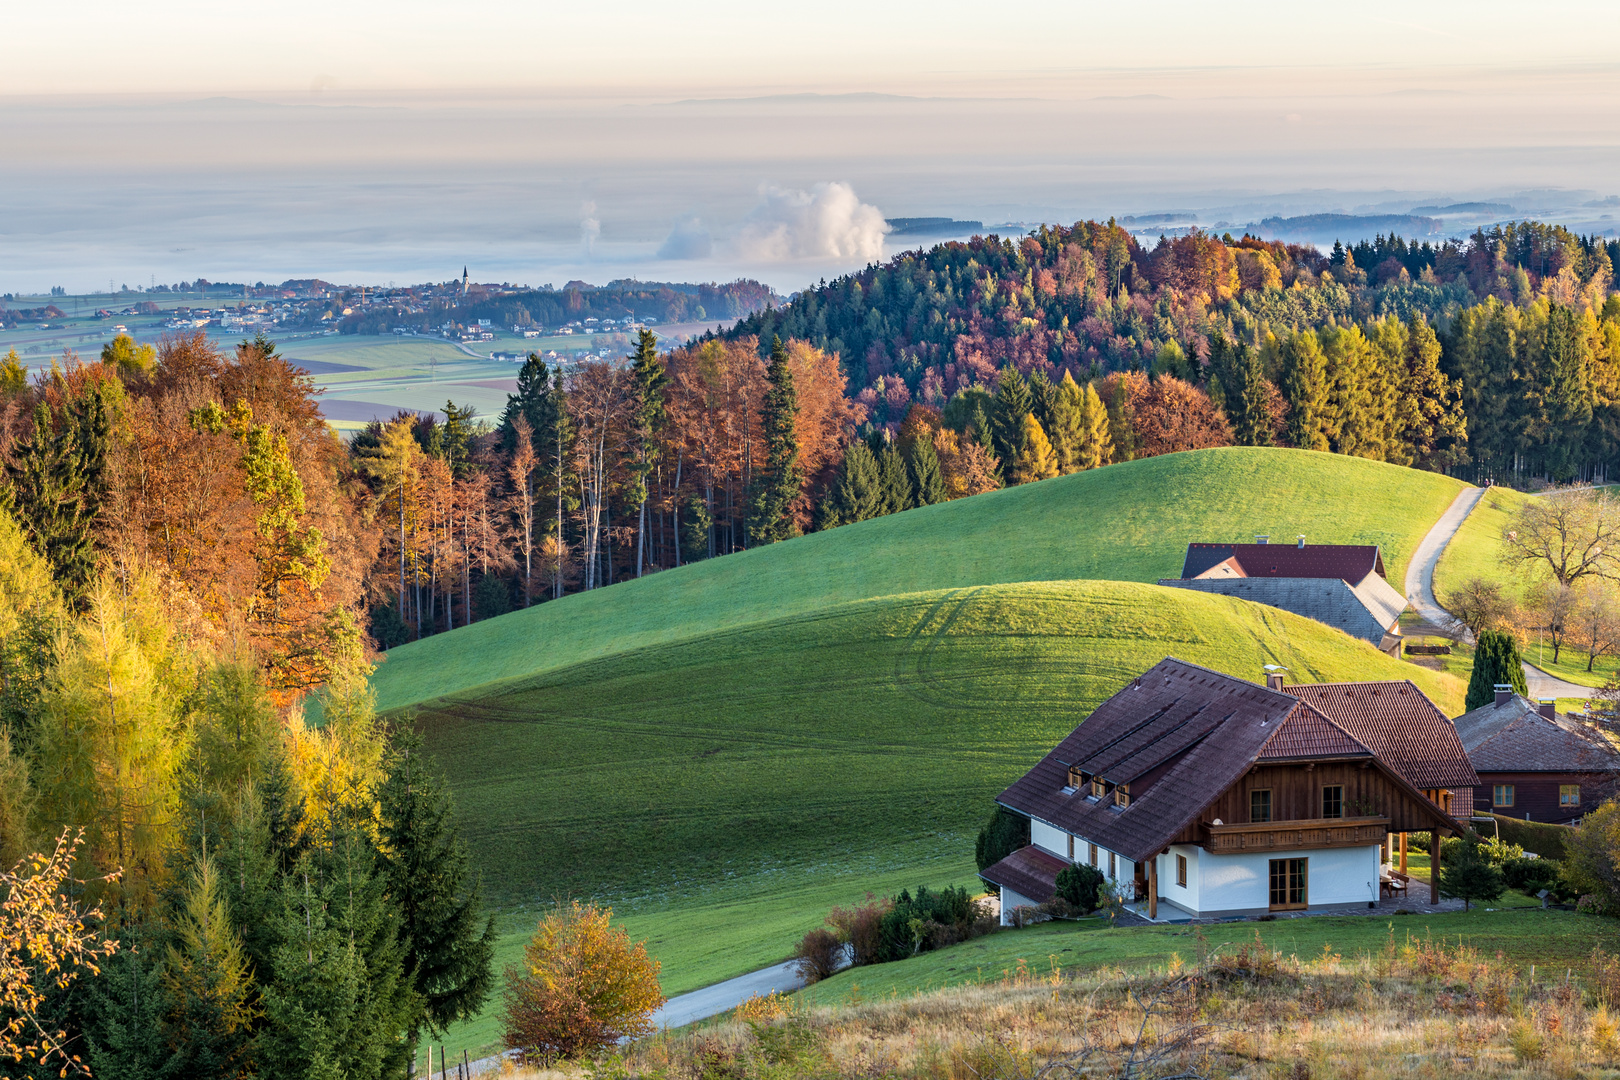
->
1192;844;1380;912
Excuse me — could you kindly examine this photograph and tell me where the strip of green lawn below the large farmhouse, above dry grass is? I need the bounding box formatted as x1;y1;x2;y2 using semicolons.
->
799;897;1620;1004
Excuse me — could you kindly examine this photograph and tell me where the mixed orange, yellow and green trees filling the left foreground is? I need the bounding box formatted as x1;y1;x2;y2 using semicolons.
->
0;335;492;1080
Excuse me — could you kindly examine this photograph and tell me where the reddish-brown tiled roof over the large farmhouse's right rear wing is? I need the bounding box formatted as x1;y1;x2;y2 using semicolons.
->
1283;678;1479;790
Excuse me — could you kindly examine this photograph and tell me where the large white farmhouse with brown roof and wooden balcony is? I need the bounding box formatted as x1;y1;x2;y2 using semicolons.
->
980;657;1479;918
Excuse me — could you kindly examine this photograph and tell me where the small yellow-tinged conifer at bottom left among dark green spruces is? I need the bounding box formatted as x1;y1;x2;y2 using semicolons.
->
164;855;256;1080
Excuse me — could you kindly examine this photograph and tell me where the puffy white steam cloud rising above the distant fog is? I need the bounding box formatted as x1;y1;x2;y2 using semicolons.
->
732;181;889;262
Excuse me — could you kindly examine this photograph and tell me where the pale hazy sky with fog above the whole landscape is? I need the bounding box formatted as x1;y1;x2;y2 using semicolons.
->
0;0;1620;291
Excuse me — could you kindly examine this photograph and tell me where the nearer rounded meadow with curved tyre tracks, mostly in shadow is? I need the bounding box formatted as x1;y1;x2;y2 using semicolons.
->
416;581;1463;1049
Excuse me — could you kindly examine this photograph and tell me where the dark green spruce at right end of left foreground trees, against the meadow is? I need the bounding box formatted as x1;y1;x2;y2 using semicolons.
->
376;732;496;1048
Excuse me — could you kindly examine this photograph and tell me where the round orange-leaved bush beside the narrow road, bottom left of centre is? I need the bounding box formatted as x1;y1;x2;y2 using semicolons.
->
501;900;664;1065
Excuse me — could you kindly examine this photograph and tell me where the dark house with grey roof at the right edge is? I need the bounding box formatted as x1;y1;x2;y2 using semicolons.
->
1455;685;1620;823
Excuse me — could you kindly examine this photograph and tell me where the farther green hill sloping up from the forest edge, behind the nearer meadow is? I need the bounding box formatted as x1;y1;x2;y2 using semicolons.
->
374;447;1463;711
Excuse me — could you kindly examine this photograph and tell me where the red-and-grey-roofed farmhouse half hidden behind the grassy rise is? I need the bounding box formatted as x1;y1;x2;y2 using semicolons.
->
1158;536;1406;656
